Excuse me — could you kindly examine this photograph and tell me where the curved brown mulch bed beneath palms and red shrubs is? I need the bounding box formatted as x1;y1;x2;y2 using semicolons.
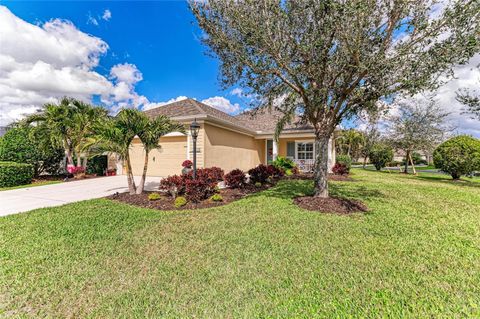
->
107;185;271;210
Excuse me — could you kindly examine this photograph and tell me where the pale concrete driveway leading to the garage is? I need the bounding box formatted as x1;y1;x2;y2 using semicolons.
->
0;175;160;216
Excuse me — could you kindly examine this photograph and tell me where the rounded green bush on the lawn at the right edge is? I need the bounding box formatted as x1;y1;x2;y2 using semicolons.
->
433;135;480;179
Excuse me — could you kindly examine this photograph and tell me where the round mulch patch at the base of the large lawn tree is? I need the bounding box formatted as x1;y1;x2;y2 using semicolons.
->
293;196;368;215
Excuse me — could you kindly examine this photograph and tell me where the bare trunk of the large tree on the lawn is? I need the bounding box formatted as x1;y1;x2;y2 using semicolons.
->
313;134;330;198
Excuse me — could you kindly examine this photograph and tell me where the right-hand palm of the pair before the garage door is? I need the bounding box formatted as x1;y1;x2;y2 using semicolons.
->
137;113;185;194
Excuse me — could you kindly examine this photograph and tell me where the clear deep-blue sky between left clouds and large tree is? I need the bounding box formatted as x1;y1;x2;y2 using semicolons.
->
0;1;246;125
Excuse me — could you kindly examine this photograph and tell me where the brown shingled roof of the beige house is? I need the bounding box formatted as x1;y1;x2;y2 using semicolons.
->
145;99;312;134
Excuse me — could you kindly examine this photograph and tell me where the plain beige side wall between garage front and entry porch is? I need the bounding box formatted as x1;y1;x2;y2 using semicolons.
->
204;124;265;172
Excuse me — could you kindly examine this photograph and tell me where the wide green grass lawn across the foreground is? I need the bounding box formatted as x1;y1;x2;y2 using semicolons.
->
0;169;480;318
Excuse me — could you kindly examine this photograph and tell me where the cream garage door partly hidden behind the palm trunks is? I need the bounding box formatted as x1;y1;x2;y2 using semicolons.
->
130;136;187;177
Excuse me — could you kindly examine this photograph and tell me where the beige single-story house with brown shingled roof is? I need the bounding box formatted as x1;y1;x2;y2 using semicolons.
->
120;99;335;176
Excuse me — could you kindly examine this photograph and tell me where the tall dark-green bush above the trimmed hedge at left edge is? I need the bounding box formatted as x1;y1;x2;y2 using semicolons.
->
0;126;65;176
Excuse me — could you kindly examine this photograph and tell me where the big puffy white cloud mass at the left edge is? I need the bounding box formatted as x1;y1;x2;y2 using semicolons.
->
0;6;149;126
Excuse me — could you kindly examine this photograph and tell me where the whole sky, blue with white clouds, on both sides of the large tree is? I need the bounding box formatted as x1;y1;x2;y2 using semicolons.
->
0;1;480;137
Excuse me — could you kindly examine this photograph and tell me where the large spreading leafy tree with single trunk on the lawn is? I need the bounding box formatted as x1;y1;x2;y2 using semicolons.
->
190;0;480;197
